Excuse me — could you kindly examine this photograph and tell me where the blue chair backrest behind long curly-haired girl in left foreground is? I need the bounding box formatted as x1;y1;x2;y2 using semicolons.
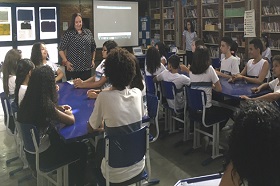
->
15;121;40;154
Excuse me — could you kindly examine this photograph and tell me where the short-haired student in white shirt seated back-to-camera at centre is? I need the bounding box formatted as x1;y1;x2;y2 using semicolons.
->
154;54;191;110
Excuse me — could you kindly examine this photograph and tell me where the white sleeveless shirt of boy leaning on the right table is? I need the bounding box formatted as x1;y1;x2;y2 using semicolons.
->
246;59;270;78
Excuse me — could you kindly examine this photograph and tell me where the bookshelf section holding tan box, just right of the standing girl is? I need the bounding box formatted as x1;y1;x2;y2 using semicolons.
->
201;0;221;58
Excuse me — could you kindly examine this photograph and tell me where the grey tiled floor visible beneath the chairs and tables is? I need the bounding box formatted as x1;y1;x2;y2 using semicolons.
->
0;80;228;186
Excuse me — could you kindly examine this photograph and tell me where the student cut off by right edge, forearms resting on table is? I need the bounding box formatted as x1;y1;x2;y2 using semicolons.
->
241;55;280;101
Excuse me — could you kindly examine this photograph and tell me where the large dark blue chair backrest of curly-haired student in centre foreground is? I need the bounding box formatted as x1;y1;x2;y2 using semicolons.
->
105;127;149;168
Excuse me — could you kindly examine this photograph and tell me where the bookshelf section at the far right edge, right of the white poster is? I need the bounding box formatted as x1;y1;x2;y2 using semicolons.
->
260;0;280;56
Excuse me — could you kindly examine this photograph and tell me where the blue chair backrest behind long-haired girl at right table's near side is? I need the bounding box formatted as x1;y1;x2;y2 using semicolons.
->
186;86;206;111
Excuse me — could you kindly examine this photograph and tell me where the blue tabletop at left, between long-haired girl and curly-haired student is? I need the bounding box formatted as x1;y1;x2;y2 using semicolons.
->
57;82;98;142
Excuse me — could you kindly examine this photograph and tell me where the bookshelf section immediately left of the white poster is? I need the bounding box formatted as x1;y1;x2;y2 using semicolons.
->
223;0;246;62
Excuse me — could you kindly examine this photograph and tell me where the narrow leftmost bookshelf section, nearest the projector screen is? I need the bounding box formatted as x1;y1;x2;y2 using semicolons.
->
149;0;162;43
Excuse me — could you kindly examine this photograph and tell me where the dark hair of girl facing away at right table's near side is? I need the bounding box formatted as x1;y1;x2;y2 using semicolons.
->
190;45;210;74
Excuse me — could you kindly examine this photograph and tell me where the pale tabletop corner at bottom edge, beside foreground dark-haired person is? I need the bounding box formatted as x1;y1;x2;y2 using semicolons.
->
174;174;222;186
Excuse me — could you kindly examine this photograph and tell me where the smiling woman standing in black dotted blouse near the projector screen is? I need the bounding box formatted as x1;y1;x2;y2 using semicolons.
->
58;13;96;80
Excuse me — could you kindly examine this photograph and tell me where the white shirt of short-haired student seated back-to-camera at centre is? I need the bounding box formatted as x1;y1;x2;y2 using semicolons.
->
156;70;191;110
